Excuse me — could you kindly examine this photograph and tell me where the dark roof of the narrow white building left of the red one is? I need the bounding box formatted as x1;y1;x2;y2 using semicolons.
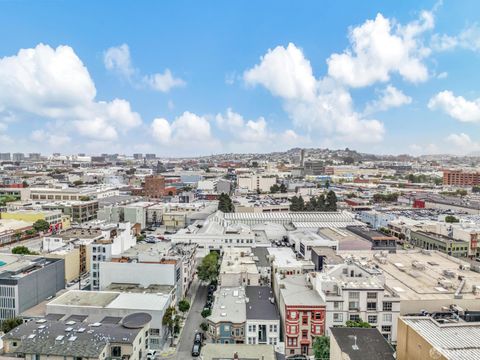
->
246;286;280;320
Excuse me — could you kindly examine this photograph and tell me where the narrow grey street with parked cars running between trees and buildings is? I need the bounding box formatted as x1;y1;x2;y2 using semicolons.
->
176;285;207;360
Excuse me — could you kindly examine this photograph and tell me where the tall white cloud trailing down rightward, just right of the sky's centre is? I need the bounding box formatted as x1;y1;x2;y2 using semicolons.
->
244;43;384;142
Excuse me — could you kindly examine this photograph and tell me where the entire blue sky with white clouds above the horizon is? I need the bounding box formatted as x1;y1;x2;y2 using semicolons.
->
0;0;480;156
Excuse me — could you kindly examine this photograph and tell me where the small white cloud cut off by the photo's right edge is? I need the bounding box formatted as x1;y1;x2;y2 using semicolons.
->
428;90;480;122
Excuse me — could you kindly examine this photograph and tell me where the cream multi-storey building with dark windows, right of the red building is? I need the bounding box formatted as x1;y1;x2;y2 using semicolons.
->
309;261;400;343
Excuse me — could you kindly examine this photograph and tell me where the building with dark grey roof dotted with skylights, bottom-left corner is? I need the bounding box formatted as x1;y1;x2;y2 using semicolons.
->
3;312;151;360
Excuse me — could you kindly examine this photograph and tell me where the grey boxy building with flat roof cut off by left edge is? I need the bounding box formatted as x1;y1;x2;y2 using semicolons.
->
0;254;65;321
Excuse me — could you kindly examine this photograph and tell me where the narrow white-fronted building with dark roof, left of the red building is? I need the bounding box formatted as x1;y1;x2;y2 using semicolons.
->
245;286;281;345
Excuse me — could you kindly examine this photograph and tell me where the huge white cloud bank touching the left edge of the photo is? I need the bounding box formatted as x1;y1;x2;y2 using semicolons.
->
0;44;142;140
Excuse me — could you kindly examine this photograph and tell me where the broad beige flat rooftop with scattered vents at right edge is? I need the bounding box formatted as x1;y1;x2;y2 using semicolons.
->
338;249;480;303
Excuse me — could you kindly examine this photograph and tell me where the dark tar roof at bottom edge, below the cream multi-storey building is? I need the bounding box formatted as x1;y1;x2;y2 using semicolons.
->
330;327;395;360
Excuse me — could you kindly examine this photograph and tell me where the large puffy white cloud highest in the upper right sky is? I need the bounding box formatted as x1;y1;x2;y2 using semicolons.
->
327;11;434;87
